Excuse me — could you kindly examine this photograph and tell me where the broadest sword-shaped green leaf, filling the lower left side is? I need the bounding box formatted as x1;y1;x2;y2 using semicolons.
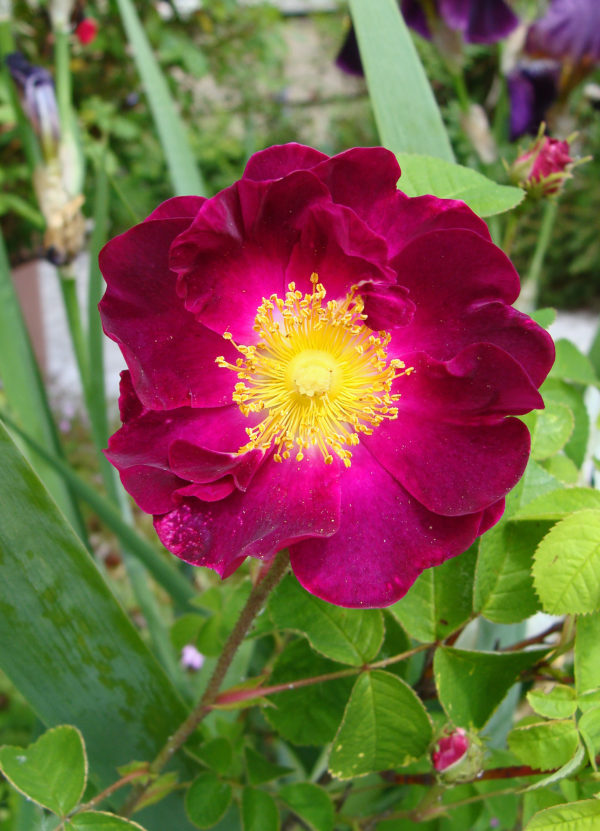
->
0;425;196;831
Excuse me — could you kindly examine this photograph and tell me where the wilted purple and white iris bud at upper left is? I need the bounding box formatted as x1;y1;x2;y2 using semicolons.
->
6;52;60;160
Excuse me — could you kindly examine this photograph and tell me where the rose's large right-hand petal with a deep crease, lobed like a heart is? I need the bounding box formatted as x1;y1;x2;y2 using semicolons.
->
363;344;543;516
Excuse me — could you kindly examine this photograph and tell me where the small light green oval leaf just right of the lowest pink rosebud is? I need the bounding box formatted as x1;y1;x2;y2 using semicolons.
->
507;719;579;770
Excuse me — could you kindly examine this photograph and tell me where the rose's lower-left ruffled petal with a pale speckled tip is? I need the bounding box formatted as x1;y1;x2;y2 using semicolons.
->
154;453;340;577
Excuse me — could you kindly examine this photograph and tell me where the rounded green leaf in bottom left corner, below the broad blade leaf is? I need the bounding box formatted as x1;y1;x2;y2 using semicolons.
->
0;725;87;817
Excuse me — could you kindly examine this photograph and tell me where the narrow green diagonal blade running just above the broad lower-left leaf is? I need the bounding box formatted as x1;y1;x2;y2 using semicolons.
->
0;412;195;611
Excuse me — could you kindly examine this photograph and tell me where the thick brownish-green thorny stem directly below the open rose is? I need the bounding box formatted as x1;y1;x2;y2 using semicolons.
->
121;550;289;816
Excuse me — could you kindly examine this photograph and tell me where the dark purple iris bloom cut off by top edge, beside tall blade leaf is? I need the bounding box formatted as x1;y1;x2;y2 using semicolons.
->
402;0;519;43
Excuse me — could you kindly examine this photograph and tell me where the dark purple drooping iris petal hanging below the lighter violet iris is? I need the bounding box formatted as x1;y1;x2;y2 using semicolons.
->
506;61;560;141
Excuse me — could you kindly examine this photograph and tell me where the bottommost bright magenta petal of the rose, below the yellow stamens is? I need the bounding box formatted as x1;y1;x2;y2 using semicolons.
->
290;446;481;608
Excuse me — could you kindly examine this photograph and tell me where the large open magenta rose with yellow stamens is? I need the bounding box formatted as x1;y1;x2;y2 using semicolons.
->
100;144;553;607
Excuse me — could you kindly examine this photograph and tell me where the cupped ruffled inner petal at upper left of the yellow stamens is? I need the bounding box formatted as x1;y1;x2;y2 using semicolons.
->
170;171;329;343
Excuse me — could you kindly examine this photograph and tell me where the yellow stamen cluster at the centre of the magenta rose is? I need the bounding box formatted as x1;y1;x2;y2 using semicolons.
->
216;274;412;467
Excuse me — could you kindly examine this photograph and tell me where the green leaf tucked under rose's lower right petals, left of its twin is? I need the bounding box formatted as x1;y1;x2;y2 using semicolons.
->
389;546;477;643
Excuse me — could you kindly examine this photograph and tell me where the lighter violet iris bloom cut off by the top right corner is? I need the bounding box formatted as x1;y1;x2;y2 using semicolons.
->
526;0;600;66
